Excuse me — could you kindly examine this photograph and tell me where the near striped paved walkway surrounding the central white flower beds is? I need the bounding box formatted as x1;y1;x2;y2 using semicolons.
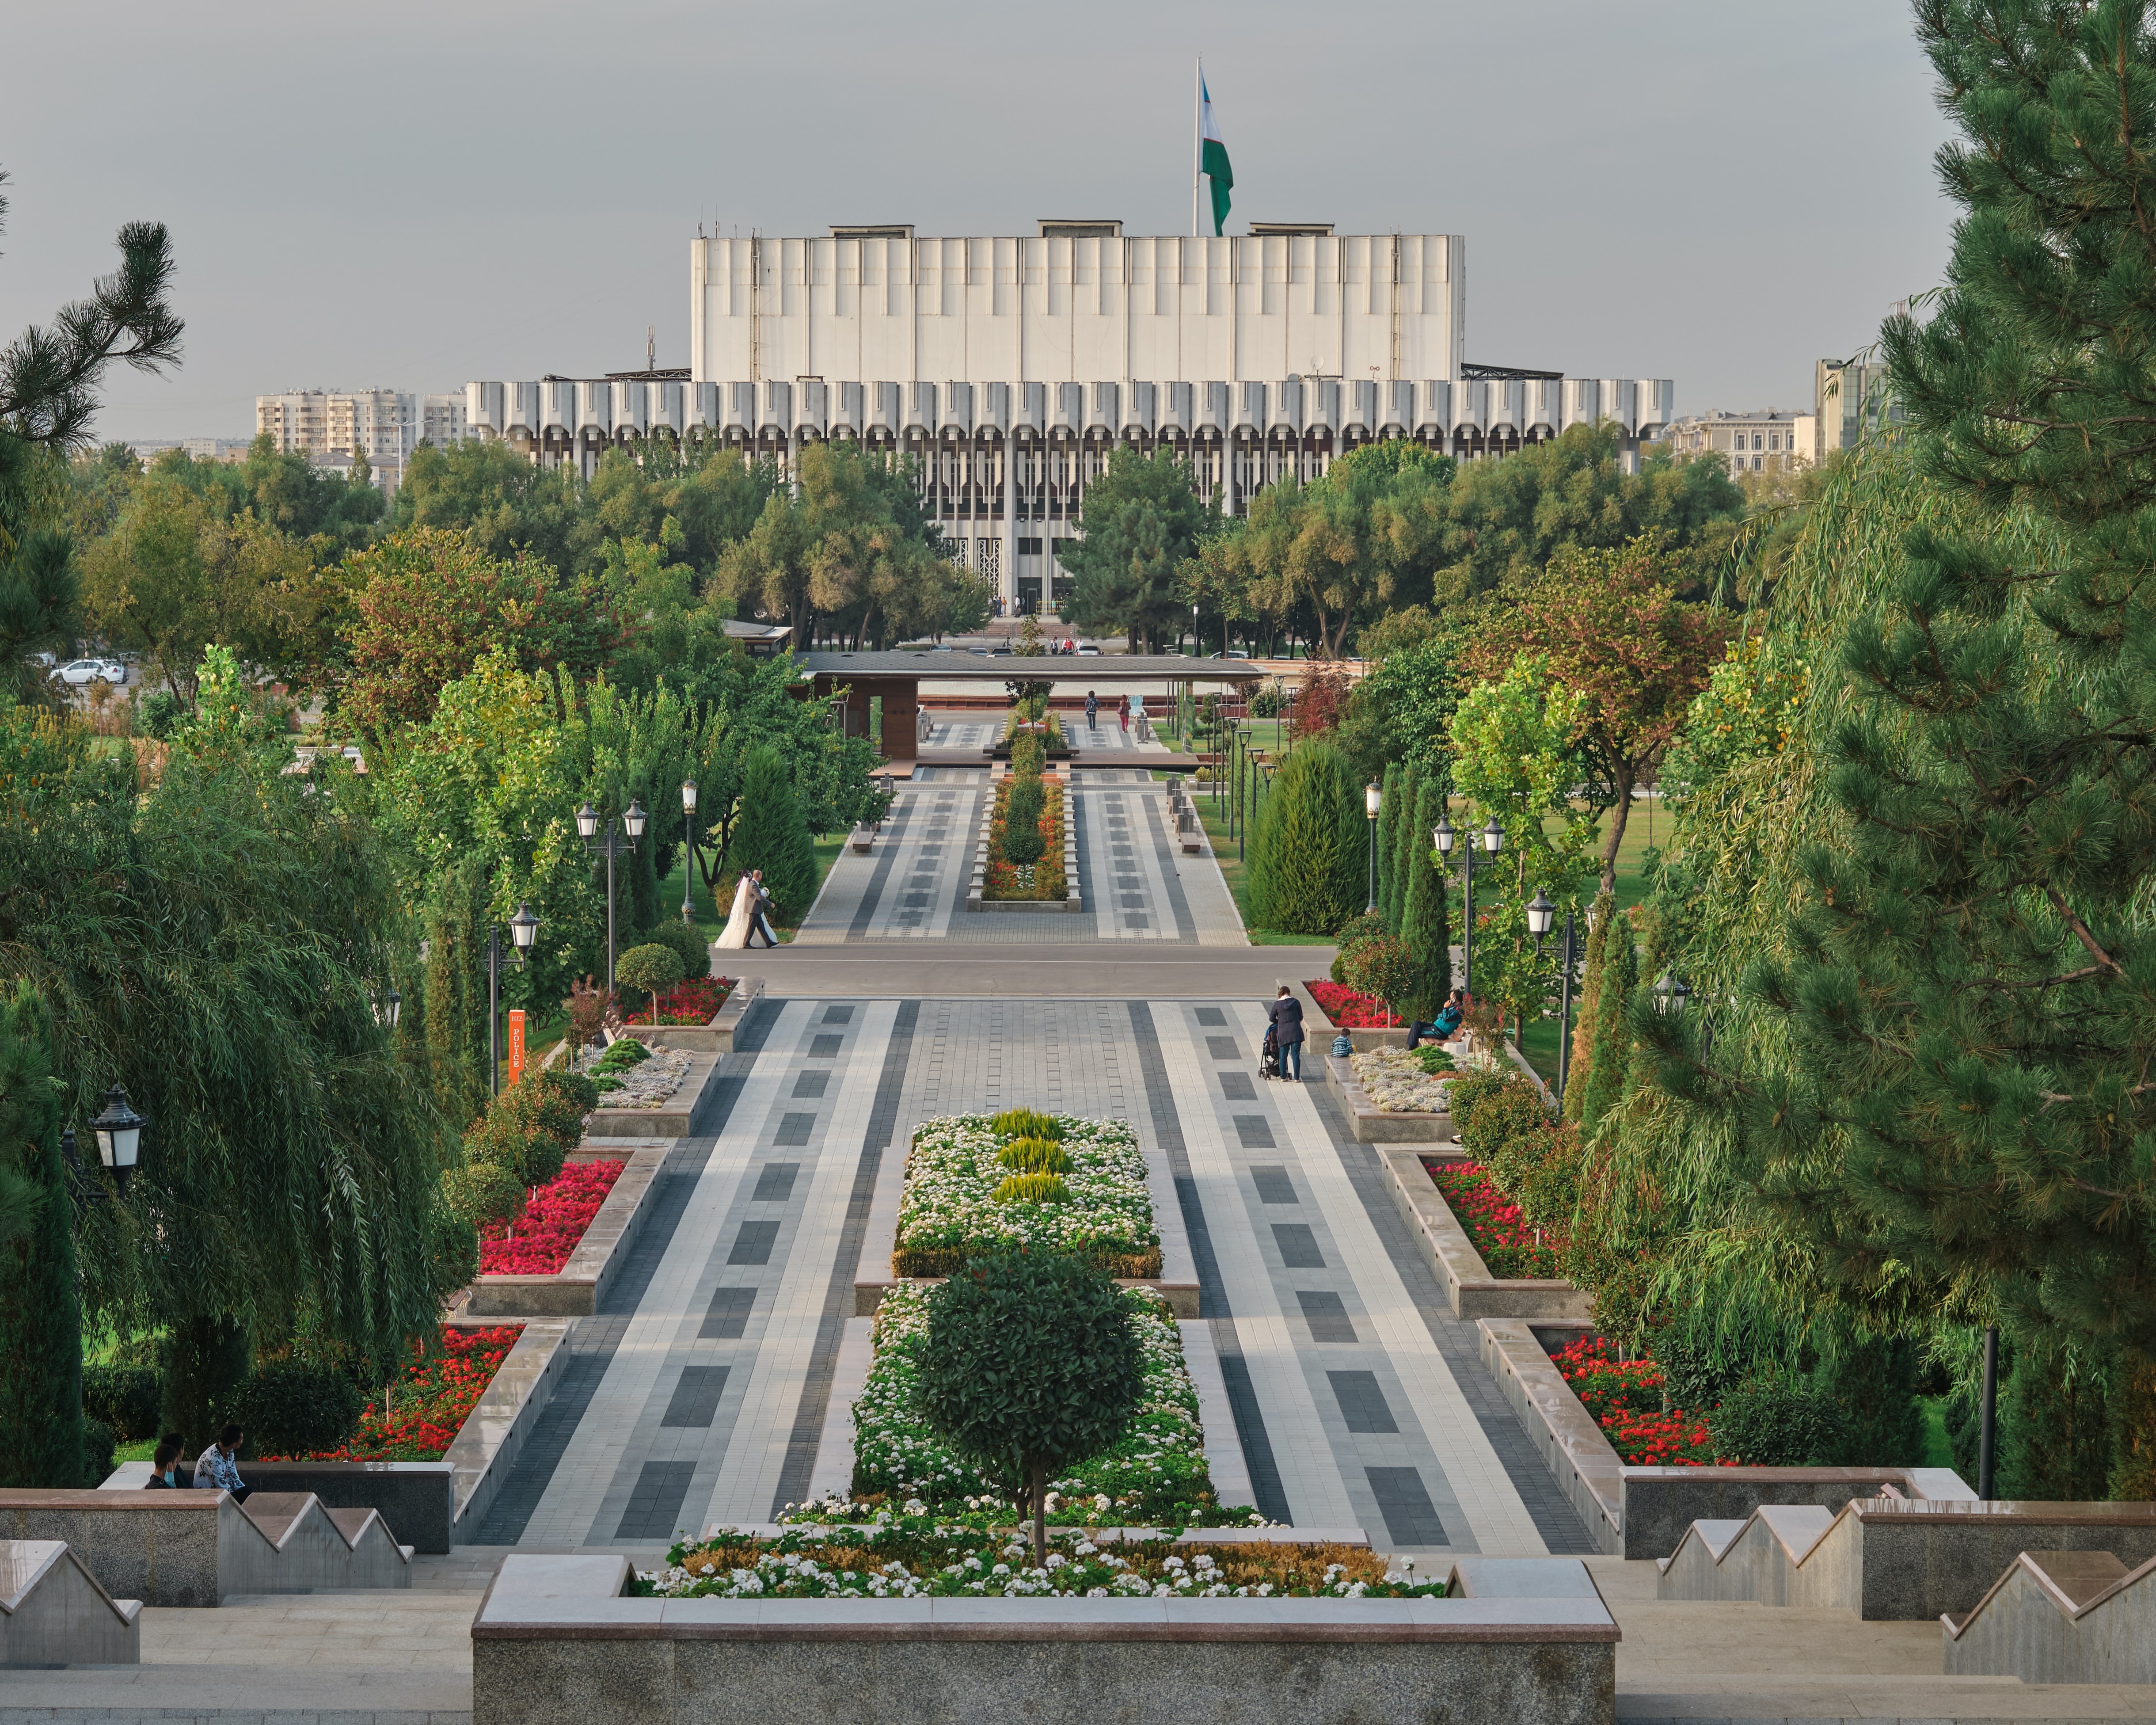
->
468;998;1587;1555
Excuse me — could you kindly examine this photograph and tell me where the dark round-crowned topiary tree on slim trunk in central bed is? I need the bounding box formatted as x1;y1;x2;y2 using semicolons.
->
920;1251;1141;1563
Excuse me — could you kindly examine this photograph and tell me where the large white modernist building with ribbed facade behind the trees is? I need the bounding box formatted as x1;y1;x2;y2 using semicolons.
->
466;220;1675;608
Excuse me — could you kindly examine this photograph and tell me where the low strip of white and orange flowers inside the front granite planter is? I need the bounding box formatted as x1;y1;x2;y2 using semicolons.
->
630;1516;1447;1600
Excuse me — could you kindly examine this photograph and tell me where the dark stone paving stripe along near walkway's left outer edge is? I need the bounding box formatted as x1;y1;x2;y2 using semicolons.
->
472;998;780;1546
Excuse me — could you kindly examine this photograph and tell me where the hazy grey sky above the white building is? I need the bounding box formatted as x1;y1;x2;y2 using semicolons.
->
0;0;1951;440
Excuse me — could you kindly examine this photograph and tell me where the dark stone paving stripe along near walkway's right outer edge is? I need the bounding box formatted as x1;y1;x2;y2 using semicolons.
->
1276;1069;1597;1557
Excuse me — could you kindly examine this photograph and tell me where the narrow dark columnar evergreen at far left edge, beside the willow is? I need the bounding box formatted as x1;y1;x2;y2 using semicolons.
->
0;981;97;1488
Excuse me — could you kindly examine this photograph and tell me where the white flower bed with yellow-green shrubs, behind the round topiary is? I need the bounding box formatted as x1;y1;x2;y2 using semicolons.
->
890;1115;1160;1279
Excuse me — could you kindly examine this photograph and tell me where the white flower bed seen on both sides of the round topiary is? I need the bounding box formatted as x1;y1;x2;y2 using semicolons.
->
840;1285;1263;1527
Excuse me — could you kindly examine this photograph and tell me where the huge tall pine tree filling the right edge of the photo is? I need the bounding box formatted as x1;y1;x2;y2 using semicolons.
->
1656;0;2156;1497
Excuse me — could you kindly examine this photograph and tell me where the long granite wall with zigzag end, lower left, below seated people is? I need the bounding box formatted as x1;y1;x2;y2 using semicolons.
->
0;1490;412;1607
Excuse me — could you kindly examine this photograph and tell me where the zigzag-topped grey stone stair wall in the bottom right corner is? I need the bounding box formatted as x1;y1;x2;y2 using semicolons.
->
1940;1550;2156;1684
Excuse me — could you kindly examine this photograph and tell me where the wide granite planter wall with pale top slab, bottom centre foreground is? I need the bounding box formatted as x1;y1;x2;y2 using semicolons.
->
472;1555;1617;1725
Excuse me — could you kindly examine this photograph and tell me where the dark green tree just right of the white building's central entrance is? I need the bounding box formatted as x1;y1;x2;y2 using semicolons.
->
1061;449;1214;653
